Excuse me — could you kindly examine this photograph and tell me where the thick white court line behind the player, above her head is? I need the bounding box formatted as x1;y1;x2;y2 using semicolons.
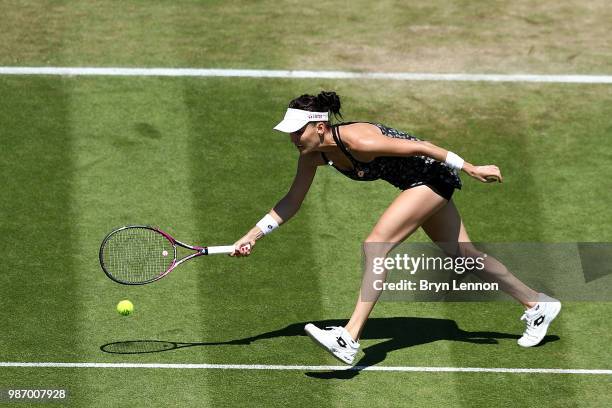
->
0;67;612;84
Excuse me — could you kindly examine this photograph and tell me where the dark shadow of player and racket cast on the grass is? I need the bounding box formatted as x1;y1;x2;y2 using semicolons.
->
100;317;559;379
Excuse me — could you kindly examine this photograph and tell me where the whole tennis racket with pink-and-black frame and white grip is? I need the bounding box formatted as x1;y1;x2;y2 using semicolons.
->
100;225;235;285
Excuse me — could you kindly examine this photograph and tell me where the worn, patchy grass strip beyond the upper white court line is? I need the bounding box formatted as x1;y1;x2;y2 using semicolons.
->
0;0;612;74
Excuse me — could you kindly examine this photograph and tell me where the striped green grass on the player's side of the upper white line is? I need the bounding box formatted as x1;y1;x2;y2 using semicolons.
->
0;77;610;406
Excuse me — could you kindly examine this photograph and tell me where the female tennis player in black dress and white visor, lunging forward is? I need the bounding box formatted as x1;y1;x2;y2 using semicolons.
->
233;92;561;364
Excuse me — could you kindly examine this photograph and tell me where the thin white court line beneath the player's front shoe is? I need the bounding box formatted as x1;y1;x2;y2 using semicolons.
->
0;362;612;375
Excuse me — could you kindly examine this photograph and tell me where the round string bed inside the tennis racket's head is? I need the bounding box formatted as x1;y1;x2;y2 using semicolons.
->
102;227;175;283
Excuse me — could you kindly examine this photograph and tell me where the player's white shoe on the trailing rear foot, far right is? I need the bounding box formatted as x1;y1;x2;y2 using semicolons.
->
518;293;561;347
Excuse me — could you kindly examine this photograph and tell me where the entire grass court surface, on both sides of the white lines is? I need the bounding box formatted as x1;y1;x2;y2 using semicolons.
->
0;1;612;407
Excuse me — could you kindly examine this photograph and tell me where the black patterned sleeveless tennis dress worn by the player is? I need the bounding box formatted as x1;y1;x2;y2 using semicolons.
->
321;122;461;200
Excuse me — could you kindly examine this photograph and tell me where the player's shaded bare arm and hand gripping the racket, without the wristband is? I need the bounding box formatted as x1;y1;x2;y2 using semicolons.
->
233;152;323;256
